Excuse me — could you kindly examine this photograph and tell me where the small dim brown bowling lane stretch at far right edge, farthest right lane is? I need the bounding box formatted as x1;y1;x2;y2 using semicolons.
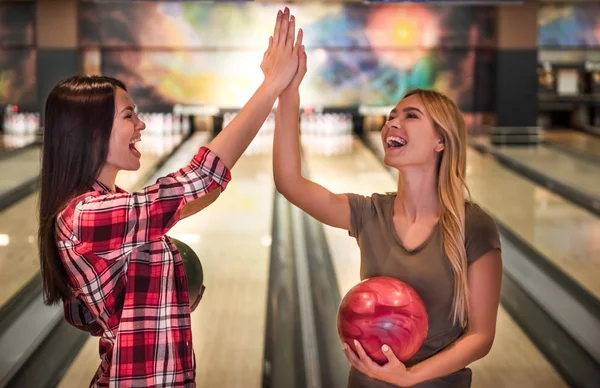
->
542;129;600;163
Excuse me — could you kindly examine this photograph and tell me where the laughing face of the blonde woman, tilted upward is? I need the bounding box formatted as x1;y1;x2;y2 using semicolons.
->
381;95;444;169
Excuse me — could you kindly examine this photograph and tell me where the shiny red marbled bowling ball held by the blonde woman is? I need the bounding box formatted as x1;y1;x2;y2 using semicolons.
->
338;276;429;365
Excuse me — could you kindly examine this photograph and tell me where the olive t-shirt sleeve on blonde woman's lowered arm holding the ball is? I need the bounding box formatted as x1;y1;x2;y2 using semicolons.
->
465;203;501;265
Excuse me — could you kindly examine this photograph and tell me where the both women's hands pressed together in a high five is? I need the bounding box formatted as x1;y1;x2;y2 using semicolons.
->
260;7;306;95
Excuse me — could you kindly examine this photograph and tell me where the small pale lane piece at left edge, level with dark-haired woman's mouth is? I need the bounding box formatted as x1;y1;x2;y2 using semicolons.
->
0;147;42;197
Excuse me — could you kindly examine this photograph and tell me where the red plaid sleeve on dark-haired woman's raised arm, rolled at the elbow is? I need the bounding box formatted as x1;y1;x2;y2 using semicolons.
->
57;147;231;258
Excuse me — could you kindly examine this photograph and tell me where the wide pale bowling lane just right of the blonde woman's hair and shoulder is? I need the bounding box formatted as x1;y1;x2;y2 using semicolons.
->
371;134;600;299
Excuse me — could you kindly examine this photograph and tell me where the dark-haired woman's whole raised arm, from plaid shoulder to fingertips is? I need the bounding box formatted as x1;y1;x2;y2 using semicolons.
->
57;7;298;255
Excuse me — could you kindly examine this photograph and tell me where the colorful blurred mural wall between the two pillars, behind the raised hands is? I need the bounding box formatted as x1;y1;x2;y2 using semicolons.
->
80;2;496;111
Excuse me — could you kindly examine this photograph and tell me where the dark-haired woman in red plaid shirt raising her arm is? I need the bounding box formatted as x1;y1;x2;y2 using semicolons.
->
39;8;301;387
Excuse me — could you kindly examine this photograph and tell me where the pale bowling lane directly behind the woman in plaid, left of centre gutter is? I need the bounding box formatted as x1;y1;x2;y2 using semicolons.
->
59;141;274;388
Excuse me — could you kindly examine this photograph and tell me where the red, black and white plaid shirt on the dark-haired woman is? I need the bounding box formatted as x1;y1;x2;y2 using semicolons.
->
56;147;231;387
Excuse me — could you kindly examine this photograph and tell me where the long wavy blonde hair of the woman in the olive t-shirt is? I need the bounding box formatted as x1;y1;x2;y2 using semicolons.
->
404;89;469;327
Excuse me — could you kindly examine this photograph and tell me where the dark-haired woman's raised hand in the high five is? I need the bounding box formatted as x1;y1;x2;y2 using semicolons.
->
260;7;299;94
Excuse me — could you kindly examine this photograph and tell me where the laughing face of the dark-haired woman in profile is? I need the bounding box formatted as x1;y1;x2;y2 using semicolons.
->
106;88;146;171
